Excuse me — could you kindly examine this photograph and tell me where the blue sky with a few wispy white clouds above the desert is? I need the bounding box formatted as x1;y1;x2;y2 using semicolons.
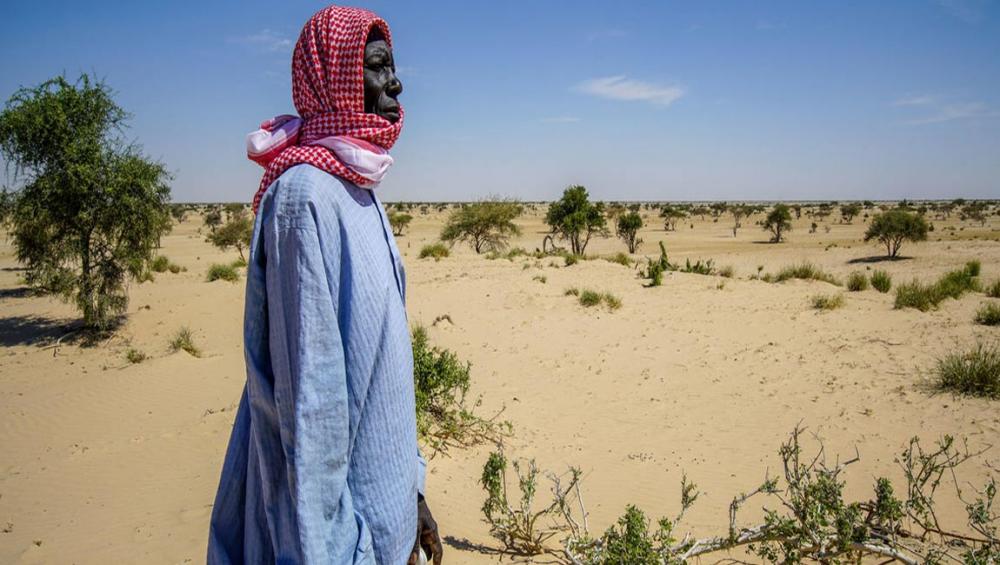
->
0;0;1000;201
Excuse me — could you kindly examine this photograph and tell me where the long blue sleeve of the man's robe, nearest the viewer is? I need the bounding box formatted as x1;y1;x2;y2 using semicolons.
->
265;221;371;563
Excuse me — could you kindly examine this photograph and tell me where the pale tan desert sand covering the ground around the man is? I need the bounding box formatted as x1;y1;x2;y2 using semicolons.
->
0;207;1000;564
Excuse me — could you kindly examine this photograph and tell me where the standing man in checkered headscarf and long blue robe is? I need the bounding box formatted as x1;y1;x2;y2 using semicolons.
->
208;6;441;565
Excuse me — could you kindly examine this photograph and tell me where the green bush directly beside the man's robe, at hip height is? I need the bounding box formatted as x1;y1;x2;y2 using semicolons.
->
412;326;510;456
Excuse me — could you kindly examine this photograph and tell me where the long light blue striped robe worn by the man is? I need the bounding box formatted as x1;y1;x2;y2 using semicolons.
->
208;165;424;565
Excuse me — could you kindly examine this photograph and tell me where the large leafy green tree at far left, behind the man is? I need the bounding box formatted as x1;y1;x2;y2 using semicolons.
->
0;75;170;329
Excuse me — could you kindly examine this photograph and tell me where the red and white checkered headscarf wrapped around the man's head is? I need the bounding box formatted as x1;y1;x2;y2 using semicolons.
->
247;6;403;212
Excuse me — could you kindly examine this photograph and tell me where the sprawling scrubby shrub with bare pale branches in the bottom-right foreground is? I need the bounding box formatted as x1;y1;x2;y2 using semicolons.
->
490;427;1000;565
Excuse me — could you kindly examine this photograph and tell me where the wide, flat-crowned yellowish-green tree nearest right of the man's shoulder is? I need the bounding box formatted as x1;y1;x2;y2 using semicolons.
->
441;198;524;253
